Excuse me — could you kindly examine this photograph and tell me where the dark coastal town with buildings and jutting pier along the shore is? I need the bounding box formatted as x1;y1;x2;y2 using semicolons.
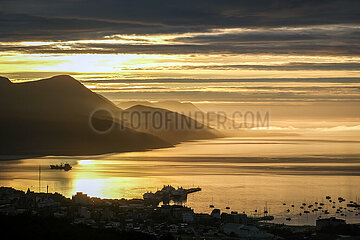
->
0;186;360;239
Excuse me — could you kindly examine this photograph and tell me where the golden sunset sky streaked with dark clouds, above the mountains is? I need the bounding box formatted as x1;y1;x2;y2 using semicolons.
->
0;0;360;119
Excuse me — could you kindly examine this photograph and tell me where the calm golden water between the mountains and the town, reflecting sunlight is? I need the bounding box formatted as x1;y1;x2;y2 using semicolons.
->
0;136;360;224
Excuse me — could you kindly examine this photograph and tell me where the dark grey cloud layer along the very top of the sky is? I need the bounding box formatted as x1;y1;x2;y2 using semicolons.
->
0;0;360;40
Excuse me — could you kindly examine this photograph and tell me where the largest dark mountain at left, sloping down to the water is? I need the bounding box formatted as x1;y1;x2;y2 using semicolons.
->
0;75;172;156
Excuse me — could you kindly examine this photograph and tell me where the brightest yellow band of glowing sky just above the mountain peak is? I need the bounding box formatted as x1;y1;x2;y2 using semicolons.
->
0;25;360;80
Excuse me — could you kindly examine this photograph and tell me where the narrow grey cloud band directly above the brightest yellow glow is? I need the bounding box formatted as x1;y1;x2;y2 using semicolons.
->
0;42;360;56
